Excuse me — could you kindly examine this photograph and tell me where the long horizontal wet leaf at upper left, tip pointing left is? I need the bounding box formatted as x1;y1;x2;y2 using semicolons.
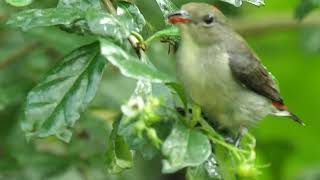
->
7;8;84;30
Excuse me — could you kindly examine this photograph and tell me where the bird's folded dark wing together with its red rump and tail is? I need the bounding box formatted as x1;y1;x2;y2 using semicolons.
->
224;31;304;125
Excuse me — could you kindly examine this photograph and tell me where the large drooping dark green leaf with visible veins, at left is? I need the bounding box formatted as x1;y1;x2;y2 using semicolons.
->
22;43;105;142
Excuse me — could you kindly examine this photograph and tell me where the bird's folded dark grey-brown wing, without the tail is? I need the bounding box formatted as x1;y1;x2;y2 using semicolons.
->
228;43;283;104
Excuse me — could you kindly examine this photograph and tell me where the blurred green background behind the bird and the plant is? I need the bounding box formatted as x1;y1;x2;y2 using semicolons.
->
0;0;320;180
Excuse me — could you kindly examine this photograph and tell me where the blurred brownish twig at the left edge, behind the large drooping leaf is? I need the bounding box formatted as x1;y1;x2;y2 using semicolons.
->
0;42;40;69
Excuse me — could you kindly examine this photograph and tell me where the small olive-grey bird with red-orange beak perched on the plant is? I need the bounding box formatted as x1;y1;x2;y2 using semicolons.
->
168;3;303;135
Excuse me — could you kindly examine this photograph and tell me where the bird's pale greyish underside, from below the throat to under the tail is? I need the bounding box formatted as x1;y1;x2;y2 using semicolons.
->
177;47;273;129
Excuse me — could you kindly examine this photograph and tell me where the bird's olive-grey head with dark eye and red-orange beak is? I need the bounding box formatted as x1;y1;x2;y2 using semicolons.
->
168;3;226;44
